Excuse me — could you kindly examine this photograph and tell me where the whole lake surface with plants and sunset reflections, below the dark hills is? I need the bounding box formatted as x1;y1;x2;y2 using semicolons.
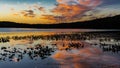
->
0;28;120;68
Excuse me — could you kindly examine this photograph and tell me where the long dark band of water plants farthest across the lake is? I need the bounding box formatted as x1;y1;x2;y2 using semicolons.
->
0;32;120;43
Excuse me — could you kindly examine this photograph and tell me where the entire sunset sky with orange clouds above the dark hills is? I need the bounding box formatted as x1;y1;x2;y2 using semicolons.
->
0;0;120;24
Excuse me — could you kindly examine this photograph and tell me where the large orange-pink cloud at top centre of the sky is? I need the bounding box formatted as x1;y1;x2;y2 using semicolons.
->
52;0;101;19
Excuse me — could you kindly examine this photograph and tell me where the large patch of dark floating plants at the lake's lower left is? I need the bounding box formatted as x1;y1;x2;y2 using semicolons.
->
0;44;54;62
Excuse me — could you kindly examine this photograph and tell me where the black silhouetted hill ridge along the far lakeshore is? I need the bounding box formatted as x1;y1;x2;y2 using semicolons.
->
0;15;120;29
